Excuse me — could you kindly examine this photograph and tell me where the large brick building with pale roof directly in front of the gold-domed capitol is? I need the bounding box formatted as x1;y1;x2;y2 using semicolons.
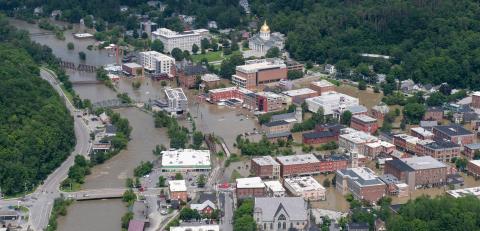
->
232;59;287;89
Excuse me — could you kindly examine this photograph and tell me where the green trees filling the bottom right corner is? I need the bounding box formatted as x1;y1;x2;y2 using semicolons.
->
387;196;480;231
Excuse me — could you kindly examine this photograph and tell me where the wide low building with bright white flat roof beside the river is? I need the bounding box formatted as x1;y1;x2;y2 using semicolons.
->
162;149;212;172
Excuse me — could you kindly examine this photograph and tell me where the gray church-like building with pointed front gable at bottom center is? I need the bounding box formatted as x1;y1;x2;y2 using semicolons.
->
253;197;310;230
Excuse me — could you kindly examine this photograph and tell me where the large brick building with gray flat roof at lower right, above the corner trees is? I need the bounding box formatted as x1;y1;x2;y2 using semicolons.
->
384;156;447;190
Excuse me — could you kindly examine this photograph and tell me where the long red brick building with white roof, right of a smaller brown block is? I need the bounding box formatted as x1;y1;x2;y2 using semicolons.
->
277;154;320;177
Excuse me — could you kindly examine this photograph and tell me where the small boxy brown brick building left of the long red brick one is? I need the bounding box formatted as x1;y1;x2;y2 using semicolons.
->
250;156;280;179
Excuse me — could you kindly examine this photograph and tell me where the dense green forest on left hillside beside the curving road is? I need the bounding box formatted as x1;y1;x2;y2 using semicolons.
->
0;15;75;195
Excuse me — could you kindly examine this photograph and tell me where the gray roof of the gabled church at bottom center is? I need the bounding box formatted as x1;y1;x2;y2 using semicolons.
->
254;197;308;221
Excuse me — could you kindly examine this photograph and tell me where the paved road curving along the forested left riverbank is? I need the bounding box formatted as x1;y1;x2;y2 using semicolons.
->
0;69;90;231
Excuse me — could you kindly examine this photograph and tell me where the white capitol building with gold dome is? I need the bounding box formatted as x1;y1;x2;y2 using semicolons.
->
248;21;285;56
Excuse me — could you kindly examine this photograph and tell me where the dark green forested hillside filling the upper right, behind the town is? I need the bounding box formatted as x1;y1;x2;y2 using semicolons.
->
252;0;480;89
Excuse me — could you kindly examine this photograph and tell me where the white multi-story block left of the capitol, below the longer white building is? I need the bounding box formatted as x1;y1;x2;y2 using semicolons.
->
139;51;175;77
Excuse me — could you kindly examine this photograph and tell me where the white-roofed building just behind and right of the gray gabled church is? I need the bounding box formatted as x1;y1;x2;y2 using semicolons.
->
285;176;326;201
